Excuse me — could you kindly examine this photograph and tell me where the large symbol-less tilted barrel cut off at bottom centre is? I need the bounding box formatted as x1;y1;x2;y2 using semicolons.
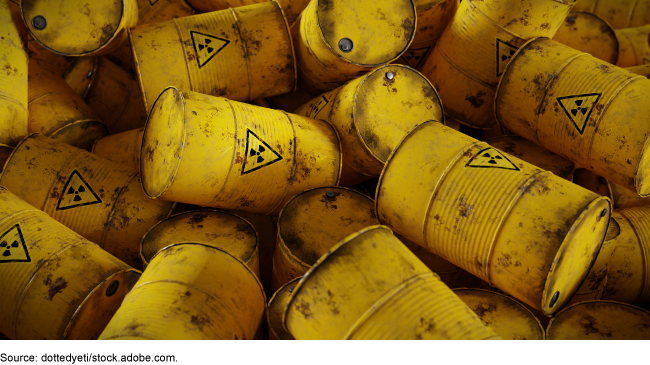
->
284;226;500;340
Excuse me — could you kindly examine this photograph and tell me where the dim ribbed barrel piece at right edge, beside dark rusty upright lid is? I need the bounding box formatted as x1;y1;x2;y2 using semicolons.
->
616;25;650;67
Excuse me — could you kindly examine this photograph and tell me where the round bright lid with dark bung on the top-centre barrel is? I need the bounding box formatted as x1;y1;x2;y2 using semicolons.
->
316;0;416;66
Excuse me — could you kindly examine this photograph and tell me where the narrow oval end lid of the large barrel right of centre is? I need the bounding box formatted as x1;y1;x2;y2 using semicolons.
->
541;197;611;315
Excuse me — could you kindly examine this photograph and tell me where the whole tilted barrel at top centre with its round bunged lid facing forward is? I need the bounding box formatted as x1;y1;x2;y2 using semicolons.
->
291;0;416;95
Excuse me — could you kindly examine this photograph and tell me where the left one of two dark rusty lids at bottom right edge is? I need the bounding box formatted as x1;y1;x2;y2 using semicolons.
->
454;288;546;340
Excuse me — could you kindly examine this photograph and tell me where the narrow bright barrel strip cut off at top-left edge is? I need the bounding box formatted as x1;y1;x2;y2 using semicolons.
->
0;0;28;146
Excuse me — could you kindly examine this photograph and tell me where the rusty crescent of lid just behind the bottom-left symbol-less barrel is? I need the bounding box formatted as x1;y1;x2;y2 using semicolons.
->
140;209;258;265
